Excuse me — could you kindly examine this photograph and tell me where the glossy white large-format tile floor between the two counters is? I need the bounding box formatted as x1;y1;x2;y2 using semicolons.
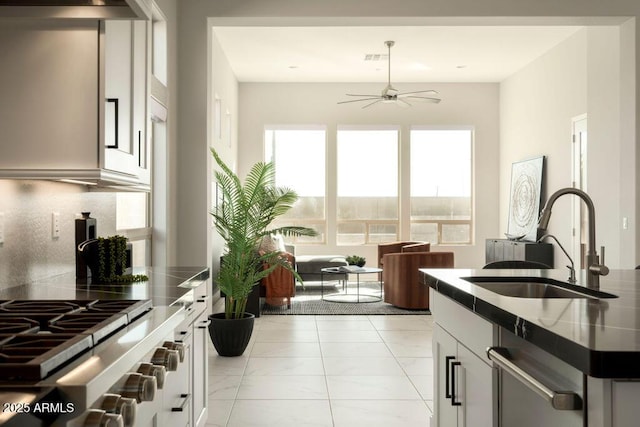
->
207;308;433;427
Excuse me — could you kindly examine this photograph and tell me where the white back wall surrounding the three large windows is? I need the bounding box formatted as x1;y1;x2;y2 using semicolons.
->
238;83;499;268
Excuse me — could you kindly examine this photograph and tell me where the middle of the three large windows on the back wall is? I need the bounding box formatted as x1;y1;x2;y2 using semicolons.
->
336;128;399;245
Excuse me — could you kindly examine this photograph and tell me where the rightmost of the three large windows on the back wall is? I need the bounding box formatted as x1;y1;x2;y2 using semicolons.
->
410;128;473;244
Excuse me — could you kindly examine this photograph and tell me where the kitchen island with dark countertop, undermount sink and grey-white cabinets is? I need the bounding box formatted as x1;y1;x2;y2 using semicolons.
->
421;269;640;427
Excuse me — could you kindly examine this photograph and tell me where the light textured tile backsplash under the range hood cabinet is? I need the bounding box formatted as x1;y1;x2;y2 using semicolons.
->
0;180;116;288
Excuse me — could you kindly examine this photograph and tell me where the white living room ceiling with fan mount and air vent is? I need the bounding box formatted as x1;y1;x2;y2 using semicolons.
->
213;26;583;82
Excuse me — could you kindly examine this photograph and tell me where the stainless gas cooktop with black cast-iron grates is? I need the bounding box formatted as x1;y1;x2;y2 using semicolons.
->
0;300;152;383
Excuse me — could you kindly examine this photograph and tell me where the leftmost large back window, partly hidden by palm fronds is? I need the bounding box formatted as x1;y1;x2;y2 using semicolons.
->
264;127;326;243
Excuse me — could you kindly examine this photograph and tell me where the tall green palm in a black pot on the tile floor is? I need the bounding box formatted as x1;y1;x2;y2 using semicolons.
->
209;149;317;356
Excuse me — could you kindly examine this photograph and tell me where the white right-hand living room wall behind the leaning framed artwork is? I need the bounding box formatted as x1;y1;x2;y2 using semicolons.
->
500;30;587;266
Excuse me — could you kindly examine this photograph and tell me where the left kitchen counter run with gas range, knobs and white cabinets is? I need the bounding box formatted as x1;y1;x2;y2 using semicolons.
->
0;267;209;427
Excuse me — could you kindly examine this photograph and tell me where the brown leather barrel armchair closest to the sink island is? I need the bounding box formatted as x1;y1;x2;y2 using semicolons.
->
383;252;453;309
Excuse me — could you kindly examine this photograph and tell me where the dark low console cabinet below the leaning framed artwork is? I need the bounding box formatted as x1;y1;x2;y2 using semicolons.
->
485;239;553;268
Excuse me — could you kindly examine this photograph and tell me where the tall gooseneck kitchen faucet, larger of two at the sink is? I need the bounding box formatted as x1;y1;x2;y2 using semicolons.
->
538;187;609;289
